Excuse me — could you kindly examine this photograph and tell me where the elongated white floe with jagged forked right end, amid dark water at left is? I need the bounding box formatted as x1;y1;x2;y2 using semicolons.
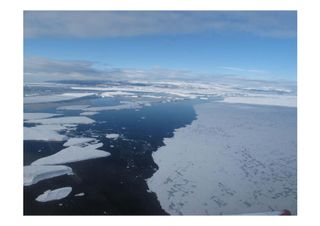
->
31;143;110;165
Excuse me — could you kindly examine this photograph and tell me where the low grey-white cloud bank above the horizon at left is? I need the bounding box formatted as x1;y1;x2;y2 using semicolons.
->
24;57;210;82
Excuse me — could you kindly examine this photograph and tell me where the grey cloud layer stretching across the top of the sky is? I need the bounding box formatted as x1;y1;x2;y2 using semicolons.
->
24;11;297;38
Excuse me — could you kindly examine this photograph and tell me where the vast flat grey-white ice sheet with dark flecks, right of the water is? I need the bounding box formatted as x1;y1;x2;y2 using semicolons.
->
147;103;297;215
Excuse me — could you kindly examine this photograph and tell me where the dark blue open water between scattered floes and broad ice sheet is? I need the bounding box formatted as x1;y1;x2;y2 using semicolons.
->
24;98;196;215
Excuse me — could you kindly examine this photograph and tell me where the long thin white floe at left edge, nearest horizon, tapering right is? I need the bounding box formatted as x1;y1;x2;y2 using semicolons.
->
23;93;95;104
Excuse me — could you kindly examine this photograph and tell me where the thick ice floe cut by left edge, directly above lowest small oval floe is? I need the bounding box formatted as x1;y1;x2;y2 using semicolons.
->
23;165;73;186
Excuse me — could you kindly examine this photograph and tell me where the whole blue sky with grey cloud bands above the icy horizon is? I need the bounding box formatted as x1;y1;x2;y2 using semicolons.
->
24;11;297;81
